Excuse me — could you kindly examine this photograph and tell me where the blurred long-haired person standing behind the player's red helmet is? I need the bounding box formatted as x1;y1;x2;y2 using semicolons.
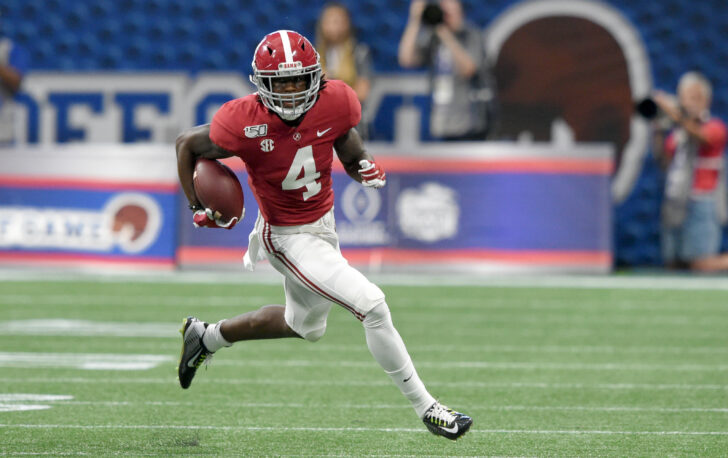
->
315;2;373;138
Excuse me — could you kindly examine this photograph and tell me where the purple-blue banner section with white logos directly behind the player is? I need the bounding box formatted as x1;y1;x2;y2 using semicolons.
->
179;144;612;272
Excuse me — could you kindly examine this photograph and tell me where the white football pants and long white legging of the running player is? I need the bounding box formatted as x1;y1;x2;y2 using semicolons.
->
245;209;435;418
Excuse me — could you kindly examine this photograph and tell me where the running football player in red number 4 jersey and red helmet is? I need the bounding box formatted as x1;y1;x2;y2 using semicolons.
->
176;30;472;439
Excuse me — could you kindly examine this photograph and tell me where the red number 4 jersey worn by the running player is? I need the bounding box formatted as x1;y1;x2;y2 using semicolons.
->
210;80;361;226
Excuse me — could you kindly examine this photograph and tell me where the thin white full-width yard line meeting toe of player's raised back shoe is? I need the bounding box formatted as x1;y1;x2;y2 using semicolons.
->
0;377;728;391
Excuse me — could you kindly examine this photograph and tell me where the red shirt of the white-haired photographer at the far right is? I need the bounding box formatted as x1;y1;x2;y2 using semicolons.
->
665;118;727;194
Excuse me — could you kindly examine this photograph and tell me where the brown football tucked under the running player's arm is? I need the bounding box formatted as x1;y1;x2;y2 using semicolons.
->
192;158;245;223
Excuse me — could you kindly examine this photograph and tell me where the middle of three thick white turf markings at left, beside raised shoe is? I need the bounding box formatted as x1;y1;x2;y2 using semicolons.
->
0;352;174;370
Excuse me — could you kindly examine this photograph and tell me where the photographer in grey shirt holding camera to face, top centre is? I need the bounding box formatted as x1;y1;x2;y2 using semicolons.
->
399;0;495;140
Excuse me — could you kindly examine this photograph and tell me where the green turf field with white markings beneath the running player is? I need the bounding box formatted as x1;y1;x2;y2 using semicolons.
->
0;281;728;456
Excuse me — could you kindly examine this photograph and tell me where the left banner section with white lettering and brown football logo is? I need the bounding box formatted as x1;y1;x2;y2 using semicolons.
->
0;145;178;269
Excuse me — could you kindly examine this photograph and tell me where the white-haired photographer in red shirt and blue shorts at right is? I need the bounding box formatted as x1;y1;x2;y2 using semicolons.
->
653;72;728;272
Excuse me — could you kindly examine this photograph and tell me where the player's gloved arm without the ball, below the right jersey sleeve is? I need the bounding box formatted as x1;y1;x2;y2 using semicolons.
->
334;127;387;188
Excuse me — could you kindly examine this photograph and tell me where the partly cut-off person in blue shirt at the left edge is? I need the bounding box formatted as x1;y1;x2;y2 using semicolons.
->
0;33;28;145
